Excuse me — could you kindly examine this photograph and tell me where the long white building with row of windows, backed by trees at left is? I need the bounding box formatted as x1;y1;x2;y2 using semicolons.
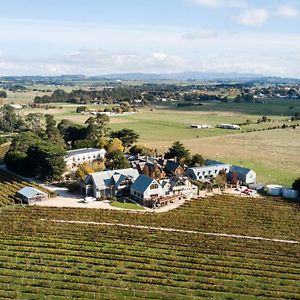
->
65;148;106;168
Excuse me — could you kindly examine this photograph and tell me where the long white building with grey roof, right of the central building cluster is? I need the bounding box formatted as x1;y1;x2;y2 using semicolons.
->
186;164;230;181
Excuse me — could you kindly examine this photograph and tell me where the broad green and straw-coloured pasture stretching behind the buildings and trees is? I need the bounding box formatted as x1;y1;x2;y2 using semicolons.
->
14;99;300;185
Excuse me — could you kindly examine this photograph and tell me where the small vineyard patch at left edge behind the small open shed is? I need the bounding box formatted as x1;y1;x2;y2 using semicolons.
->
0;170;48;207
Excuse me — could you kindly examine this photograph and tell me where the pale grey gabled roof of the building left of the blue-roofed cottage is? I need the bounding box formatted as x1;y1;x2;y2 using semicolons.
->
86;168;139;187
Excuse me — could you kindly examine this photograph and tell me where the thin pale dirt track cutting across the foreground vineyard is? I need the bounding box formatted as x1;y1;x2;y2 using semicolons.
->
40;218;300;244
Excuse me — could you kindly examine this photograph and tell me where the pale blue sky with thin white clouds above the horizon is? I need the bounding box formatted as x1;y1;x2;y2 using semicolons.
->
0;0;300;78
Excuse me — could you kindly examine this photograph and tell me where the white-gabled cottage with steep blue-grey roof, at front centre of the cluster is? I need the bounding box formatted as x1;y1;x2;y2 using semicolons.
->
130;175;164;203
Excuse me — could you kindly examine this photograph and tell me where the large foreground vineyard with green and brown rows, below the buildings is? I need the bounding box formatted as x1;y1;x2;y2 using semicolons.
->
0;196;300;300
